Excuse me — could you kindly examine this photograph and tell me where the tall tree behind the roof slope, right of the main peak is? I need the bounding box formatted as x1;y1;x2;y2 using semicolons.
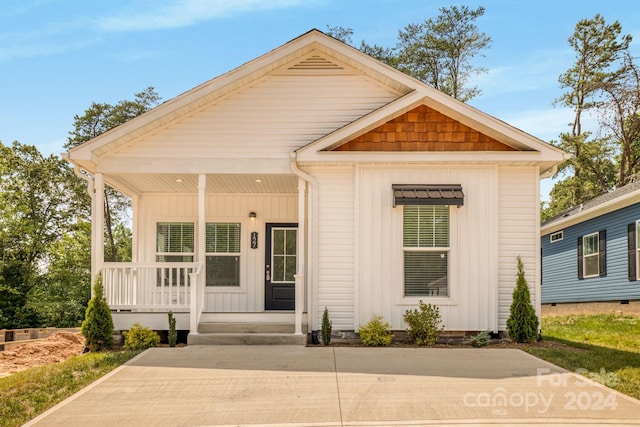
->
327;6;491;102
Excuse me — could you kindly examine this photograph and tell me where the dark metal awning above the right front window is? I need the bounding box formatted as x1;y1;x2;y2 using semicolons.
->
391;184;464;207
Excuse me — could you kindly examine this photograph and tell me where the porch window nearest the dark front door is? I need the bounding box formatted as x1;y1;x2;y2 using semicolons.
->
206;222;240;286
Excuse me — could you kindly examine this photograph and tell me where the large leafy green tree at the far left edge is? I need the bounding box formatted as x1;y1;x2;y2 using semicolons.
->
0;142;87;328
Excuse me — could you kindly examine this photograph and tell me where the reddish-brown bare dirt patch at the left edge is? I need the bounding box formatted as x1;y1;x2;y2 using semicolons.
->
0;331;84;376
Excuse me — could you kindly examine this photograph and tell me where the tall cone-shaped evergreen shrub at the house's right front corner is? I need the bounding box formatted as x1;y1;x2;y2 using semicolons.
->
507;256;539;343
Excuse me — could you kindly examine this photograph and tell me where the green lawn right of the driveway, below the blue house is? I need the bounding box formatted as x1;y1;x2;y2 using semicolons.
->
523;315;640;399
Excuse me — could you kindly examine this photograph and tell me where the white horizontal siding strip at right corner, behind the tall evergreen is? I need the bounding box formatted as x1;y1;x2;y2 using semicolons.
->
498;166;540;331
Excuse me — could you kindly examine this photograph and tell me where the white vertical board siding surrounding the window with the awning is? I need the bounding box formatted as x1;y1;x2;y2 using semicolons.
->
356;165;498;331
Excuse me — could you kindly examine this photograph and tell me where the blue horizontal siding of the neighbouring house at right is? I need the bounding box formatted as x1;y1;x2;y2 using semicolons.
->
541;203;640;304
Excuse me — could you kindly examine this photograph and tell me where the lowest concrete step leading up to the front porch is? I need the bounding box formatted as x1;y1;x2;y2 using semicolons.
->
187;332;307;345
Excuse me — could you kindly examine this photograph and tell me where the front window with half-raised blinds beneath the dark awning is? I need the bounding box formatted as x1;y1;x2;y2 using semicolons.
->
403;205;450;297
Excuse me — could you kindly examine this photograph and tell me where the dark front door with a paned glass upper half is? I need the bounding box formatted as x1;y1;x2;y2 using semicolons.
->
264;224;298;310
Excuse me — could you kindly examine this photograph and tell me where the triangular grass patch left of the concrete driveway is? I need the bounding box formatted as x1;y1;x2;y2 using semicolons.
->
0;351;138;427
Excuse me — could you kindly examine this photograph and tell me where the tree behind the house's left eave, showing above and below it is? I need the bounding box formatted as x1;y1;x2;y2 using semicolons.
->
65;86;161;261
